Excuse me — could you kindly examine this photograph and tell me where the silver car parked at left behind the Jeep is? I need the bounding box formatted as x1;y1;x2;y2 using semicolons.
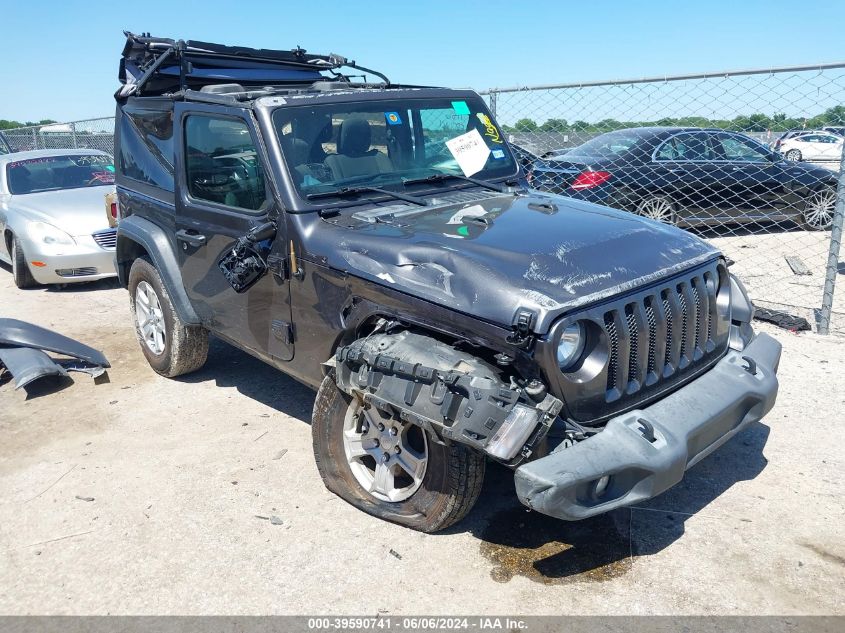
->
0;149;116;288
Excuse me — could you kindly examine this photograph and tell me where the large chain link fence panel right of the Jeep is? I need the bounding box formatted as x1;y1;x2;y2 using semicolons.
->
482;64;845;332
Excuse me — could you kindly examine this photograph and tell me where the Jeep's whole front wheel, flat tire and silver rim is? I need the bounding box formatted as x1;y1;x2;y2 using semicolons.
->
311;373;485;532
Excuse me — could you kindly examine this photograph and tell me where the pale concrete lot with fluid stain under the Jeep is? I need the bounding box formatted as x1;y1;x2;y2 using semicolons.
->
0;269;845;614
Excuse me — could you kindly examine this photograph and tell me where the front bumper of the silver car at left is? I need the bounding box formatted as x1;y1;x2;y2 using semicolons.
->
24;235;117;284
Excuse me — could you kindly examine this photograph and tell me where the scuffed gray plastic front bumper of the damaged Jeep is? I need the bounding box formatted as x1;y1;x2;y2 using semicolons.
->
515;334;781;521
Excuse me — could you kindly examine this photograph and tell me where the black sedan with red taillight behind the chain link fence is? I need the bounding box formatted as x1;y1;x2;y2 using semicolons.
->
528;127;836;229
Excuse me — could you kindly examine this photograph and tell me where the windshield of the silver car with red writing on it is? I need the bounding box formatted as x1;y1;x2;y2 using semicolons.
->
6;154;114;195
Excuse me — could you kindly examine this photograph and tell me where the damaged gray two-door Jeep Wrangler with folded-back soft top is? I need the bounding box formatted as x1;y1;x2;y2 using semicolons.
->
115;34;780;532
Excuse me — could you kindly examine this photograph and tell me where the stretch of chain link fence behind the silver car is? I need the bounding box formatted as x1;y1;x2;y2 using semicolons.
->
0;117;114;156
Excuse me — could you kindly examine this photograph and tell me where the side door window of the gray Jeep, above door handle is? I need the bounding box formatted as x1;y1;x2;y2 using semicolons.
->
185;114;267;211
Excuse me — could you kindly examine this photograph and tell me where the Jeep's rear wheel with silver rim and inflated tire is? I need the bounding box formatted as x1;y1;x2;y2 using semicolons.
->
129;257;208;378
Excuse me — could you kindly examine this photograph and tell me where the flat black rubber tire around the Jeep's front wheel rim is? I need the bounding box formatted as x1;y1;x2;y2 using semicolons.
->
311;372;486;532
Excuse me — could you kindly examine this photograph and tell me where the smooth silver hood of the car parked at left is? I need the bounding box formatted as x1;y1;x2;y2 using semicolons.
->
6;185;114;236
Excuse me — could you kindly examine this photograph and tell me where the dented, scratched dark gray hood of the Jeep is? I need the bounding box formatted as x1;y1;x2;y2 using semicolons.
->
303;192;719;332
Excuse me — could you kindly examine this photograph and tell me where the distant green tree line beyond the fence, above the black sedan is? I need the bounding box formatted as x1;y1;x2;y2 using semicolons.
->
502;106;845;134
